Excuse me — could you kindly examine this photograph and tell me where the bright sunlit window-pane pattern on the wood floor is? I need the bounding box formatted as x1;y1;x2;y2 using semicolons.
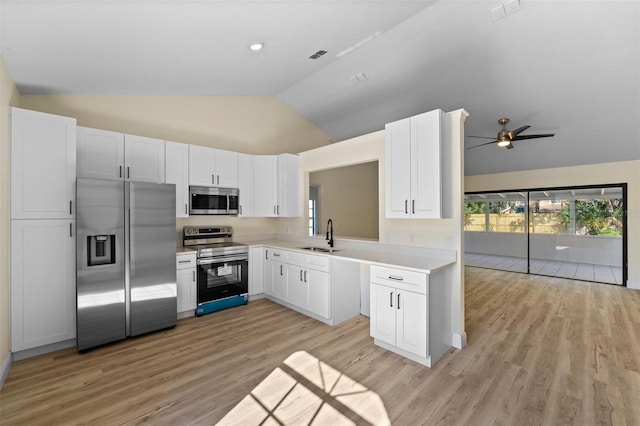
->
218;351;390;425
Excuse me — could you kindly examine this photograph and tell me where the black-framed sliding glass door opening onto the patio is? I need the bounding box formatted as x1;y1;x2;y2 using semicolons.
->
465;184;626;284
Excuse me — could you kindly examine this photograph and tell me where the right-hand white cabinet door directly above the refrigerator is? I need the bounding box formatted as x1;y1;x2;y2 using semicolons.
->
124;135;164;183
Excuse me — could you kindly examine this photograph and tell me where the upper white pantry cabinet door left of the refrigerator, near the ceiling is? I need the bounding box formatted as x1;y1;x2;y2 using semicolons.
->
11;108;76;219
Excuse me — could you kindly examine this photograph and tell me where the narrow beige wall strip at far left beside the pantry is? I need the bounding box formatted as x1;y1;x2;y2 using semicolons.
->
0;56;19;374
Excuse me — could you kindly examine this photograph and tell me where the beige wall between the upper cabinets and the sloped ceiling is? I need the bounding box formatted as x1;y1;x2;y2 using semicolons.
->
20;95;330;154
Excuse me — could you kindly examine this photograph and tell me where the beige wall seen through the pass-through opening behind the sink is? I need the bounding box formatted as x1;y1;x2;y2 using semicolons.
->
309;162;378;240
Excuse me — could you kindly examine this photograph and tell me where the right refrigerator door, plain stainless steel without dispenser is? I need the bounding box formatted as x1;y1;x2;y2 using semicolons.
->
125;182;177;336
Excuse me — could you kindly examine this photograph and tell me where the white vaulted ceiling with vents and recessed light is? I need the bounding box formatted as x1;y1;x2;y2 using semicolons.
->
0;0;640;175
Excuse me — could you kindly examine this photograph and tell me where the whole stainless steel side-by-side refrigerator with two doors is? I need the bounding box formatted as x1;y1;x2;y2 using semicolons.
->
76;179;177;351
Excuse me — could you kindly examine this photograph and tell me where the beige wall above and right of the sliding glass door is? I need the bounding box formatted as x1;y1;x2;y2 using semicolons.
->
465;161;640;289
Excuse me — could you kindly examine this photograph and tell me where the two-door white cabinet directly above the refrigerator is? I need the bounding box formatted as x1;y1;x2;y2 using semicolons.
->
78;127;165;183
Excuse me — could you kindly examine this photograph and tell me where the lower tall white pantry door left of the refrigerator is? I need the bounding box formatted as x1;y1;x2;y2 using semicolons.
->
11;220;76;352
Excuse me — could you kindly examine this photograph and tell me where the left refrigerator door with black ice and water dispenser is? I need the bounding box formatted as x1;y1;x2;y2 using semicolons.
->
76;179;126;351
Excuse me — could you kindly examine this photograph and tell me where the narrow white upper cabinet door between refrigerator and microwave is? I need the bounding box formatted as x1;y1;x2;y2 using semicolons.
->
164;141;189;217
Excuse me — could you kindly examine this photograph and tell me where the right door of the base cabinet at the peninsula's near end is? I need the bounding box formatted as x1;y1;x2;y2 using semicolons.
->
395;290;429;357
